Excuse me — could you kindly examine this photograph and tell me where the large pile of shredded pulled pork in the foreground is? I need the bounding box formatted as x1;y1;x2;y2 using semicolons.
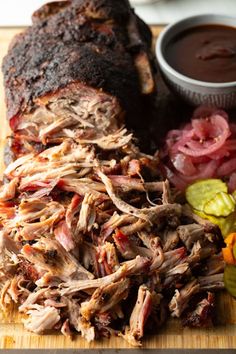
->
0;129;224;346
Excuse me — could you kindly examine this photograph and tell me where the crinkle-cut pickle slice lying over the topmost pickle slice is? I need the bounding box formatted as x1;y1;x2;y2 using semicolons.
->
203;192;235;216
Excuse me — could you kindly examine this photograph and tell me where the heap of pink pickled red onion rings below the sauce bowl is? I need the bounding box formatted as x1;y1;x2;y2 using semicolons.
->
160;107;236;190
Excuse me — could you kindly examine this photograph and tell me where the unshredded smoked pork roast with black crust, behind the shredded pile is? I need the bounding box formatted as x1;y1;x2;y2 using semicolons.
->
3;0;155;152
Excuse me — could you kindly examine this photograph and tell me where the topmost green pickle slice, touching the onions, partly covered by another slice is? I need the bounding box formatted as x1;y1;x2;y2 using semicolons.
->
186;178;228;211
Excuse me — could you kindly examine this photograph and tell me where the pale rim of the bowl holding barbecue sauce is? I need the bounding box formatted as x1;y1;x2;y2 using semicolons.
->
156;13;236;89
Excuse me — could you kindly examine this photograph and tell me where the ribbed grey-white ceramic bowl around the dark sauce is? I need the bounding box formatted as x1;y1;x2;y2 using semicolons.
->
156;14;236;108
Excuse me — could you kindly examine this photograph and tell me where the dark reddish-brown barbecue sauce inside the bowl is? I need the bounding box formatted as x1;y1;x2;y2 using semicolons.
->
164;25;236;82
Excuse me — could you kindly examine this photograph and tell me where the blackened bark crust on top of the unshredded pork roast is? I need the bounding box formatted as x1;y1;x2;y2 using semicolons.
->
3;0;154;124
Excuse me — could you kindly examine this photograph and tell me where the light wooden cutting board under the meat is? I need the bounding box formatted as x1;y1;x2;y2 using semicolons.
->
0;26;236;349
